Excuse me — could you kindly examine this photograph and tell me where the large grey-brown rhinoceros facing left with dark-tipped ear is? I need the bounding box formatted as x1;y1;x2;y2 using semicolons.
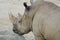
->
10;0;60;40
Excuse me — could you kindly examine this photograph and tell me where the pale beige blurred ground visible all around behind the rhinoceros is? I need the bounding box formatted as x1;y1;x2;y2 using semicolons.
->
0;0;60;40
